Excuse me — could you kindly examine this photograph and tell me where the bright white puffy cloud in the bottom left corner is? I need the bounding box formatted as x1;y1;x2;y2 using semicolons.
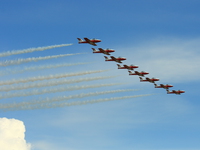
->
0;118;31;150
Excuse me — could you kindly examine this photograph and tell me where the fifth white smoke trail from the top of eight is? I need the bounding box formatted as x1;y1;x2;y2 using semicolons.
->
0;76;116;92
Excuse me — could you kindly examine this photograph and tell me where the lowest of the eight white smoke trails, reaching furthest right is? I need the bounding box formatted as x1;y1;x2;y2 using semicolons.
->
0;94;154;111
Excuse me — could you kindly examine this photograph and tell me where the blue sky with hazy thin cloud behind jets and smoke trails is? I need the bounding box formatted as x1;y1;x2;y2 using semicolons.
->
0;0;200;150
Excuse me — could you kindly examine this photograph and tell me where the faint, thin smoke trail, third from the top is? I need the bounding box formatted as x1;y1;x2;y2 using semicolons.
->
0;62;89;76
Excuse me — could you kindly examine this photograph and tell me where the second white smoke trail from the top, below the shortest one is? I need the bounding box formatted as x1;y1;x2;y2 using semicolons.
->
0;53;84;66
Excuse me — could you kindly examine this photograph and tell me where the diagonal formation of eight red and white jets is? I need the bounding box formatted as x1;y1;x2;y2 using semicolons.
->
77;38;185;95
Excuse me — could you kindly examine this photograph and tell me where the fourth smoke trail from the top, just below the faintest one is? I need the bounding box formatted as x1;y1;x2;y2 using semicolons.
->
0;70;109;85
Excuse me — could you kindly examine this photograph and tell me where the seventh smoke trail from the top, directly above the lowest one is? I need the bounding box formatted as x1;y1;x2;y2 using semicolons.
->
0;89;138;109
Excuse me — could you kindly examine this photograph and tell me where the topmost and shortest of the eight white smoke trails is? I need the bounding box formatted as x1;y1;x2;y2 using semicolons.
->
0;44;72;57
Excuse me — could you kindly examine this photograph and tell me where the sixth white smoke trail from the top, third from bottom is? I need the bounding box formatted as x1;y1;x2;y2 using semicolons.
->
0;83;122;99
